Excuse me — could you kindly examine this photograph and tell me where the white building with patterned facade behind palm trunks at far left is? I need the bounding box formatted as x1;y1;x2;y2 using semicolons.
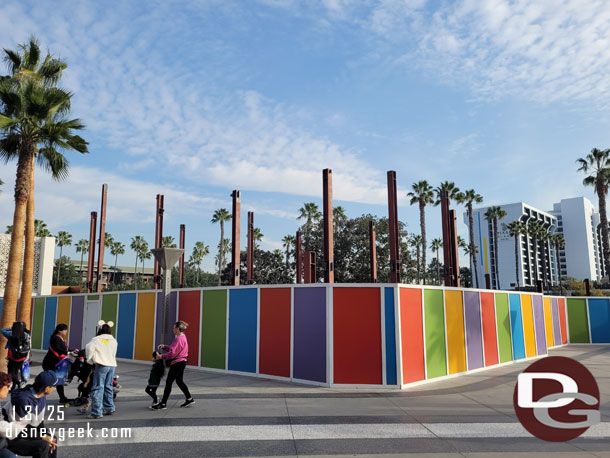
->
0;234;55;296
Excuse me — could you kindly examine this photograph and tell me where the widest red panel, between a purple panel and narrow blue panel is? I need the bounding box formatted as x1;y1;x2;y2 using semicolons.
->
333;288;383;385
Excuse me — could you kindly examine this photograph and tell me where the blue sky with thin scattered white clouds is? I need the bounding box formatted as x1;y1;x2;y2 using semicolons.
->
0;0;610;271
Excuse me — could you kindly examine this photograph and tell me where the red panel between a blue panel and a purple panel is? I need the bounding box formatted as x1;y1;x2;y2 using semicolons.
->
259;288;290;377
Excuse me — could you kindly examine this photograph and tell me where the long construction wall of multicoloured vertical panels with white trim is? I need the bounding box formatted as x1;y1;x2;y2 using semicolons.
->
23;284;610;387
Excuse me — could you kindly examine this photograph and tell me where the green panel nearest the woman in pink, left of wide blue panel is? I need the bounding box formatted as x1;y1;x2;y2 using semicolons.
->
201;289;227;369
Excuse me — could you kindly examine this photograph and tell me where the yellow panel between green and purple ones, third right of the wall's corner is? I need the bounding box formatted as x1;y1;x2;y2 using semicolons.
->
445;291;466;374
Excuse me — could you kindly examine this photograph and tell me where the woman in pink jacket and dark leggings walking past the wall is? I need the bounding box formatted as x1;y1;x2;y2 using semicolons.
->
152;321;195;410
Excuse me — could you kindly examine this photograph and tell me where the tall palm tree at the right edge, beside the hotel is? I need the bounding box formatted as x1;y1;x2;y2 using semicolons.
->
576;148;610;280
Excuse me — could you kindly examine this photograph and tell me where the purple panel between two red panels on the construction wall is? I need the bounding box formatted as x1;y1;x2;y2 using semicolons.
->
292;286;326;383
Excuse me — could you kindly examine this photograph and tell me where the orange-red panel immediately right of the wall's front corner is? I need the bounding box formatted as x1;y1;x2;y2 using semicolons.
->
400;288;426;383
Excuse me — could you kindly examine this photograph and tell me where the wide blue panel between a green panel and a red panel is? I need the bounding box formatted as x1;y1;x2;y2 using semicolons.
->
228;288;258;373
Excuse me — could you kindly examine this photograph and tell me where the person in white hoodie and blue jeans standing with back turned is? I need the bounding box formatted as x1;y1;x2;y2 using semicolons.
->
85;320;117;418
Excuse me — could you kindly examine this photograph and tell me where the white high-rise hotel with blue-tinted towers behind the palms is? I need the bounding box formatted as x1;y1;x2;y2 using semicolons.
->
464;197;604;289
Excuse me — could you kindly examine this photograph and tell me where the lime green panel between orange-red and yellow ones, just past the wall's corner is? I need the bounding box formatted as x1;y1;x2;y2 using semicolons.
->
424;290;447;379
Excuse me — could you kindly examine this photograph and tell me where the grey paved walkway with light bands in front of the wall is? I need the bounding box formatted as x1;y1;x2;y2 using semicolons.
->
25;345;610;458
